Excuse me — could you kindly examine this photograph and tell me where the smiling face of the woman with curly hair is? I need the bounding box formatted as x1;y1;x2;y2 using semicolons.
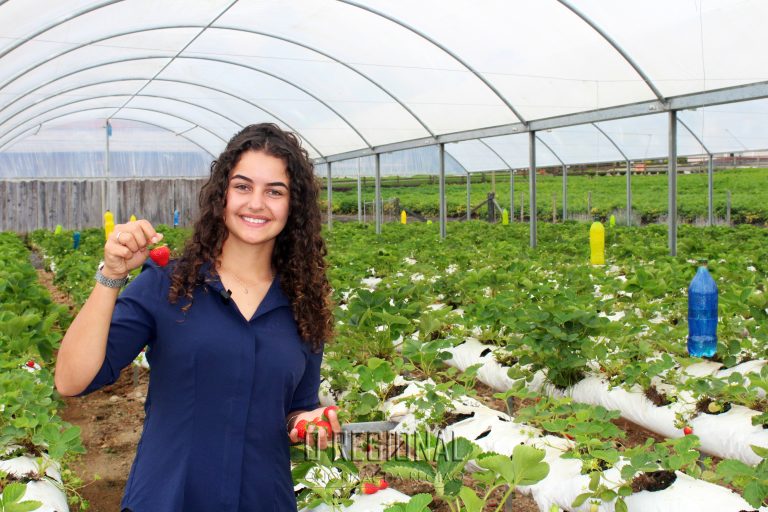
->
224;150;290;250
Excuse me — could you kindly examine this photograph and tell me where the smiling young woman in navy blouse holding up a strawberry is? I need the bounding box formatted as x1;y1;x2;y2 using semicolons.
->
55;124;341;512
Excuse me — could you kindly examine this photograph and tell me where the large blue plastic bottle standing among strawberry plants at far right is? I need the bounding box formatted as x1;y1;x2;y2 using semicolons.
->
688;263;717;357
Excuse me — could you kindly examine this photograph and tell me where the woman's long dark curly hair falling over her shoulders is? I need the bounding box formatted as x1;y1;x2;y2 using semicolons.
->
168;123;333;349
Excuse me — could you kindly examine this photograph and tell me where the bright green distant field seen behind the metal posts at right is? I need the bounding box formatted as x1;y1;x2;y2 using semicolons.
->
322;169;768;225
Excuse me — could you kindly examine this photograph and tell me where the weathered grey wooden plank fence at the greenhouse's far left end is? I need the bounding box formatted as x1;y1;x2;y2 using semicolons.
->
0;178;205;233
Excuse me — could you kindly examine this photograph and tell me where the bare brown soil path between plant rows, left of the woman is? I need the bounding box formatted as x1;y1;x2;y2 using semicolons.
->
37;269;149;512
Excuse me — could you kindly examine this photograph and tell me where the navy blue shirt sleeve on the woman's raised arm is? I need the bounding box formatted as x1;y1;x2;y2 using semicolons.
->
79;264;162;396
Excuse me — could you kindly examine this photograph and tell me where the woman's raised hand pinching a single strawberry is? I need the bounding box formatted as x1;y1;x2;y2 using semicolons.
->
101;219;163;279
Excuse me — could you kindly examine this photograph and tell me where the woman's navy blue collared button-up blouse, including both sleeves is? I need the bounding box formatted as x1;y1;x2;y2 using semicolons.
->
83;262;322;512
